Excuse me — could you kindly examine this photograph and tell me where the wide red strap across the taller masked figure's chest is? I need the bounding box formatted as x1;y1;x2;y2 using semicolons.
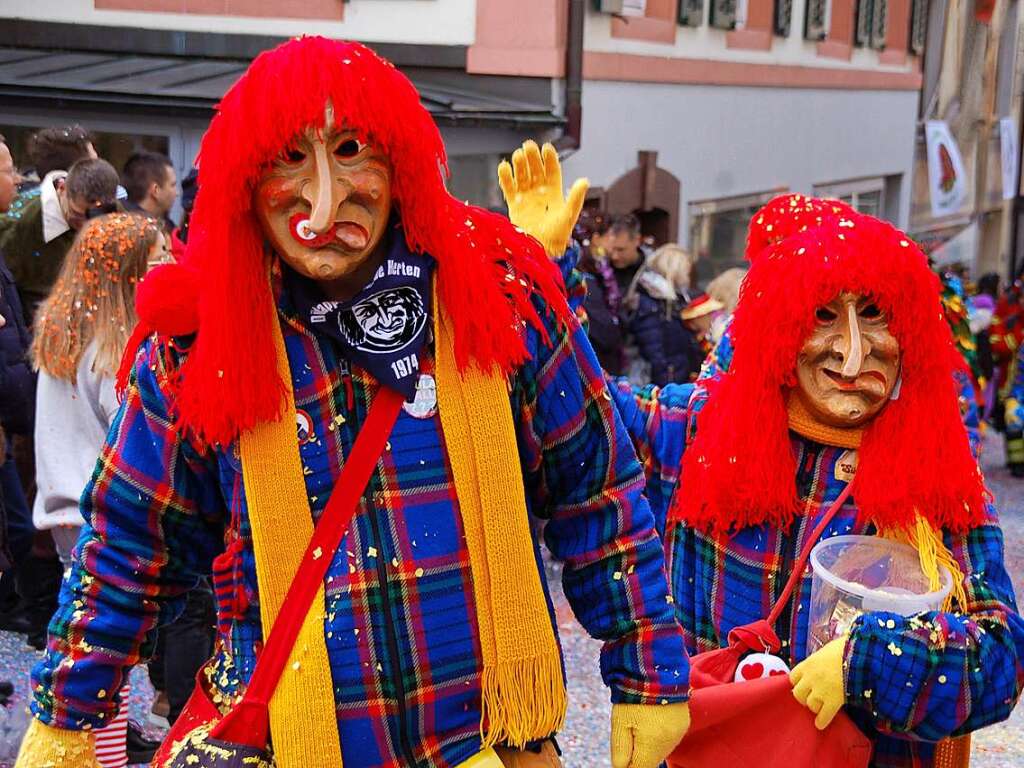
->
212;387;404;748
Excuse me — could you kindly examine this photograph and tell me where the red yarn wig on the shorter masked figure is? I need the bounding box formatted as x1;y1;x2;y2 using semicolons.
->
671;201;986;534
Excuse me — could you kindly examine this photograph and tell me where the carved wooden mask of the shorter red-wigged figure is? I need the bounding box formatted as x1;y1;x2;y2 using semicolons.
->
797;293;900;428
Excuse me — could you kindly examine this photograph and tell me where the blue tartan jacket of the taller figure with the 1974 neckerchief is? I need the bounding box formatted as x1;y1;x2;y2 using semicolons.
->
33;274;688;768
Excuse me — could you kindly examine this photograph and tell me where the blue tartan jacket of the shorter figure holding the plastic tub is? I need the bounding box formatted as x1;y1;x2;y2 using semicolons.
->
611;374;1024;768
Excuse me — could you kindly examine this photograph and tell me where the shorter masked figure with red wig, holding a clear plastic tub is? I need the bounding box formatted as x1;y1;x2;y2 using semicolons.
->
612;195;1024;767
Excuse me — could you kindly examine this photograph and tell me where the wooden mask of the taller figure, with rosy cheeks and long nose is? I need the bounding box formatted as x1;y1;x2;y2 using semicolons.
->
253;103;391;299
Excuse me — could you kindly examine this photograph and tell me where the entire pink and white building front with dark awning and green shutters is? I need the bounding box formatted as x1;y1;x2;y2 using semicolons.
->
0;0;926;280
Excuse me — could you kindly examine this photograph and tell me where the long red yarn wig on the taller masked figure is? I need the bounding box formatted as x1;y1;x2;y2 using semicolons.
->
150;37;566;443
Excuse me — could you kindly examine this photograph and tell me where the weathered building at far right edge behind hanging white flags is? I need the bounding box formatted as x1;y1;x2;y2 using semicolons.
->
910;0;1024;278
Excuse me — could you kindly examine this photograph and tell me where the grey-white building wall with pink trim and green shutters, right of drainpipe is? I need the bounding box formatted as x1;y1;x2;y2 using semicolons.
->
552;0;921;282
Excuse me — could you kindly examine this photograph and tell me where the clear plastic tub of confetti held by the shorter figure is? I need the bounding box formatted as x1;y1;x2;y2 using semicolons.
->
807;536;953;653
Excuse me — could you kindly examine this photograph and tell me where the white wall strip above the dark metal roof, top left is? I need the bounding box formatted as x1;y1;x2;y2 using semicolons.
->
0;0;476;45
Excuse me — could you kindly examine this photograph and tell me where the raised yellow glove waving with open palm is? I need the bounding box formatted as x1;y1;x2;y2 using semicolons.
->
498;141;590;259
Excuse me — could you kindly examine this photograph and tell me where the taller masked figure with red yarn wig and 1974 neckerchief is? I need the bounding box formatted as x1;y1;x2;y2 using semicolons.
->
17;38;688;768
